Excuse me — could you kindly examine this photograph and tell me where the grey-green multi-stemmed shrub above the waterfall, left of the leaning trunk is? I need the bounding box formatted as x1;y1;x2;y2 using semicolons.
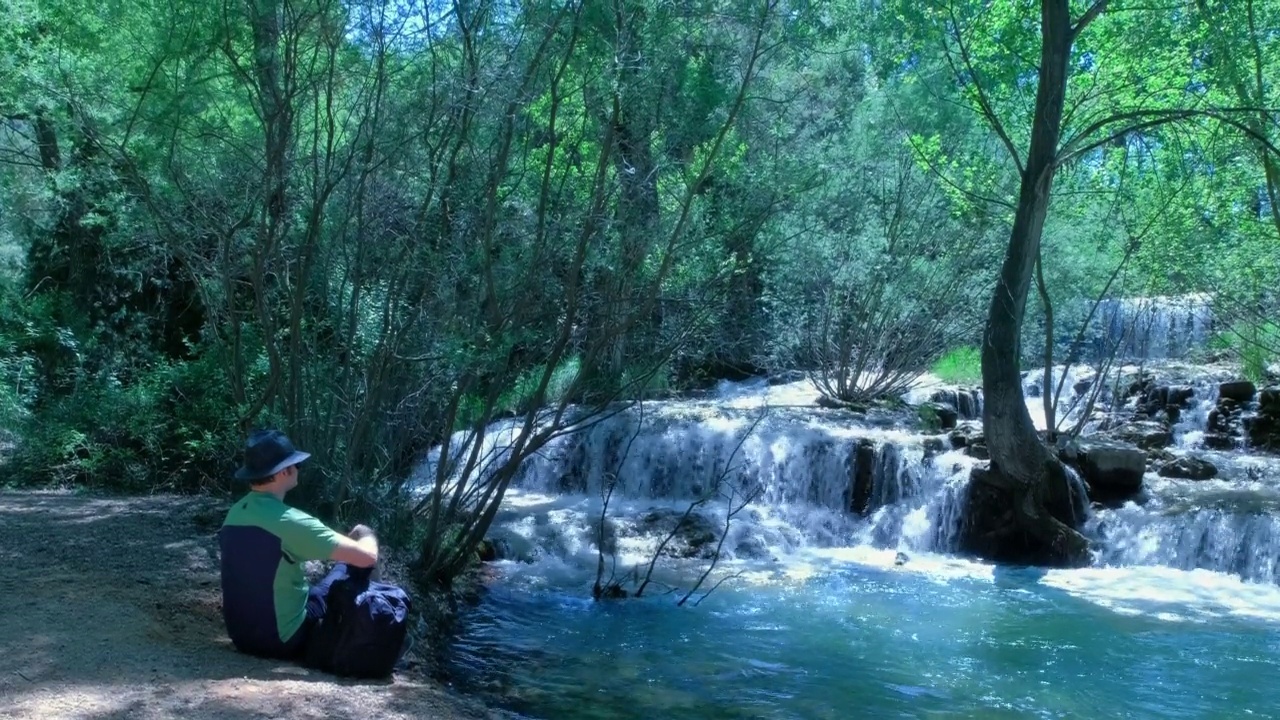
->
765;77;1002;402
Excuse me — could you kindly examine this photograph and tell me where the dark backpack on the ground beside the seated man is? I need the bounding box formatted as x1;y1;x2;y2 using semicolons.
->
303;568;412;679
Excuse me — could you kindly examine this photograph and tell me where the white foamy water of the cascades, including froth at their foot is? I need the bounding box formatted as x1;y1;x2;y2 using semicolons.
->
422;368;1280;620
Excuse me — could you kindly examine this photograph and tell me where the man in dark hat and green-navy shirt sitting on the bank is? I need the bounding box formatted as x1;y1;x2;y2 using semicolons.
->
218;430;378;660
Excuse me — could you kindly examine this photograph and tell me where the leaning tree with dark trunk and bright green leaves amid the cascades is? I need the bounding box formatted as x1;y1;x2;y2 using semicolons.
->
943;0;1275;565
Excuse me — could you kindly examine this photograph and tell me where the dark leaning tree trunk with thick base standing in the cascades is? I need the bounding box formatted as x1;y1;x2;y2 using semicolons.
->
966;0;1088;565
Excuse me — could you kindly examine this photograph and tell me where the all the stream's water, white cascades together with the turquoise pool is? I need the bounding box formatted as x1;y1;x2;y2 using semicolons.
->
435;369;1280;720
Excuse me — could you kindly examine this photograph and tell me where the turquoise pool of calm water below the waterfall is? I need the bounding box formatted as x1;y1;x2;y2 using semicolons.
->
454;557;1280;720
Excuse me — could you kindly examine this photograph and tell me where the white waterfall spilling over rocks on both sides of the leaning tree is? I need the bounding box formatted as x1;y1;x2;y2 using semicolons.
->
416;366;1280;583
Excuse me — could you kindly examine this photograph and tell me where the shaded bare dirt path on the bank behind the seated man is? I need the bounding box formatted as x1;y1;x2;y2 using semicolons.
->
0;492;509;720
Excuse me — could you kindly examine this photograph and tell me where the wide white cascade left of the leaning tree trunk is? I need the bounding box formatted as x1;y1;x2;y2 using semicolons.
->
424;394;974;562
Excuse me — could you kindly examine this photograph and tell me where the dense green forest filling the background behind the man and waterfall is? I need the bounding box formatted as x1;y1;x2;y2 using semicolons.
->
0;0;1280;582
